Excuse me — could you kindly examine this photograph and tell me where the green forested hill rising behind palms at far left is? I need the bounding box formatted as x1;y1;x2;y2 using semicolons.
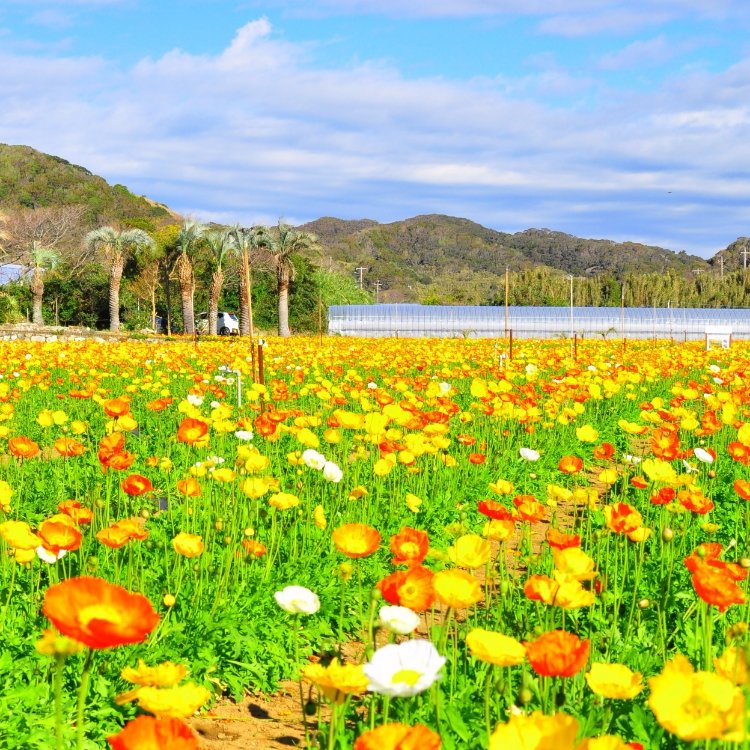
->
0;143;171;226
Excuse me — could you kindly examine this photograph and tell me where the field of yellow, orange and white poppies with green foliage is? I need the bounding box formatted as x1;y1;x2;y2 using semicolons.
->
0;338;750;750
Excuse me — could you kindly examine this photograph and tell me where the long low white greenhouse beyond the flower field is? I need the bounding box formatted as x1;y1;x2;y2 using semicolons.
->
328;304;750;340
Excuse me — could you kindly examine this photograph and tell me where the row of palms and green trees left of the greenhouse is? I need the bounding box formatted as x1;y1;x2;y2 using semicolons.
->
0;206;370;336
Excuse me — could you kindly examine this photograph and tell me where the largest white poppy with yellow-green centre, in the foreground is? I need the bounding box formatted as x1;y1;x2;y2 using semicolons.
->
362;640;445;698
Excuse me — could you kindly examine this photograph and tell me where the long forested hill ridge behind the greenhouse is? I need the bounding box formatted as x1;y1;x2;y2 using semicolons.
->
301;215;710;303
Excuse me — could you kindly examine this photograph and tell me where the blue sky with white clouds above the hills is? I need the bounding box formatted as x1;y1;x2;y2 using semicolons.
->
0;0;750;257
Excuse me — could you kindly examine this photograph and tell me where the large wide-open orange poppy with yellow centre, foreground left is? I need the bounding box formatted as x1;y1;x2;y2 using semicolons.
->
42;576;159;648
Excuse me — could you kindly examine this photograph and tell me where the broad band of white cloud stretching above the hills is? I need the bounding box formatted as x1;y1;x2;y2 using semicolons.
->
0;19;750;253
